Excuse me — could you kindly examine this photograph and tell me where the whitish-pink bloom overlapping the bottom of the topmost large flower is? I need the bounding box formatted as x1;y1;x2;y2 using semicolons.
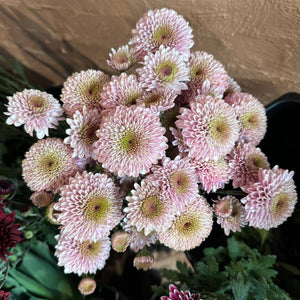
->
136;46;189;94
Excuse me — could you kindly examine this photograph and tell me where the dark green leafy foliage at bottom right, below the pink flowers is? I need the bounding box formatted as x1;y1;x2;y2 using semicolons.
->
153;238;290;300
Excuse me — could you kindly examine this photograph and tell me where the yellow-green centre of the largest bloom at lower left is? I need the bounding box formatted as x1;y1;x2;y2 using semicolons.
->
83;195;111;224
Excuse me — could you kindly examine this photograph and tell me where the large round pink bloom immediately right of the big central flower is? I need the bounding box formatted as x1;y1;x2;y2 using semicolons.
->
176;96;239;160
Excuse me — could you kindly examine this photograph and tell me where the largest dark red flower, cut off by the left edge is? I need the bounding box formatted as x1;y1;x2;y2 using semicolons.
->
0;204;22;262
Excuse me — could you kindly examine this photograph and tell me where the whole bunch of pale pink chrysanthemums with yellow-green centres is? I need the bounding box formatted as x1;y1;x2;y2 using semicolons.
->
2;8;297;296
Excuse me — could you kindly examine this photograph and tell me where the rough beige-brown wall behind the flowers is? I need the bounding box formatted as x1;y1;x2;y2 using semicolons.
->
0;0;300;104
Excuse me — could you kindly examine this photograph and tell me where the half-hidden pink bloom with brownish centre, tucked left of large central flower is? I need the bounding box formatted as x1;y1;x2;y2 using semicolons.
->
64;106;102;159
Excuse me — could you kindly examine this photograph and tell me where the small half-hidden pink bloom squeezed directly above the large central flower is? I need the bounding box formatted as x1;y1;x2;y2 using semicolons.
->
136;88;177;113
